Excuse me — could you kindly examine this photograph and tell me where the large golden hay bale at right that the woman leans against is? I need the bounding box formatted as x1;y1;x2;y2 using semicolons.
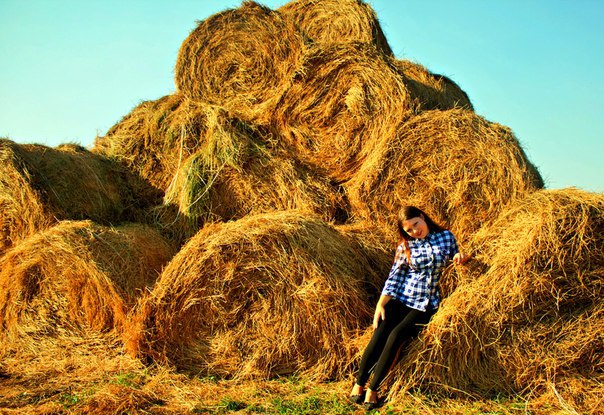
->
386;189;604;410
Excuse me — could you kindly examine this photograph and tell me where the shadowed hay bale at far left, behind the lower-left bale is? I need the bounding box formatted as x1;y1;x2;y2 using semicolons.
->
0;139;157;252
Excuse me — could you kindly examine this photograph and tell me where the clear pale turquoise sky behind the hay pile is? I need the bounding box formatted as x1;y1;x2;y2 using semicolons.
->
0;0;604;192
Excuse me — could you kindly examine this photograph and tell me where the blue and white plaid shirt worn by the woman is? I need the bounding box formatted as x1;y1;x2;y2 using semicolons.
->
382;230;459;311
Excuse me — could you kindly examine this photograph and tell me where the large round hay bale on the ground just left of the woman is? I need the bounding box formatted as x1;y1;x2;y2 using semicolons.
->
127;211;375;379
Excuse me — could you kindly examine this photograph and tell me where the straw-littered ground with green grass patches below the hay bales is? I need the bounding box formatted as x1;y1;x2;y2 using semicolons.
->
0;335;566;415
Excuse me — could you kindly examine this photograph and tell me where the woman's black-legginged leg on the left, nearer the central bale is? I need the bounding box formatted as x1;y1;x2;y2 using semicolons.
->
356;300;410;386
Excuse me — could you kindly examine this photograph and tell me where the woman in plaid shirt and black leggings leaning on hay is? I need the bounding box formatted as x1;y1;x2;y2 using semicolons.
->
350;206;469;409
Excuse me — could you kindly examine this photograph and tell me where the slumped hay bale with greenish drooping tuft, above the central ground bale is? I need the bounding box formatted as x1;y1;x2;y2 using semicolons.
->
93;95;347;242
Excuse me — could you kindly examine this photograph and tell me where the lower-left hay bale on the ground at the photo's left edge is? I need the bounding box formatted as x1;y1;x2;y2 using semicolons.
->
0;221;174;337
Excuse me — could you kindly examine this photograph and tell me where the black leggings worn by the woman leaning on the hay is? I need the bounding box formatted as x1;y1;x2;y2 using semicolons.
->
357;299;435;391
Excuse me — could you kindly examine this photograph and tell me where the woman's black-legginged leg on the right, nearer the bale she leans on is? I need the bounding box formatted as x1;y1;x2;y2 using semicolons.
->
368;306;434;393
